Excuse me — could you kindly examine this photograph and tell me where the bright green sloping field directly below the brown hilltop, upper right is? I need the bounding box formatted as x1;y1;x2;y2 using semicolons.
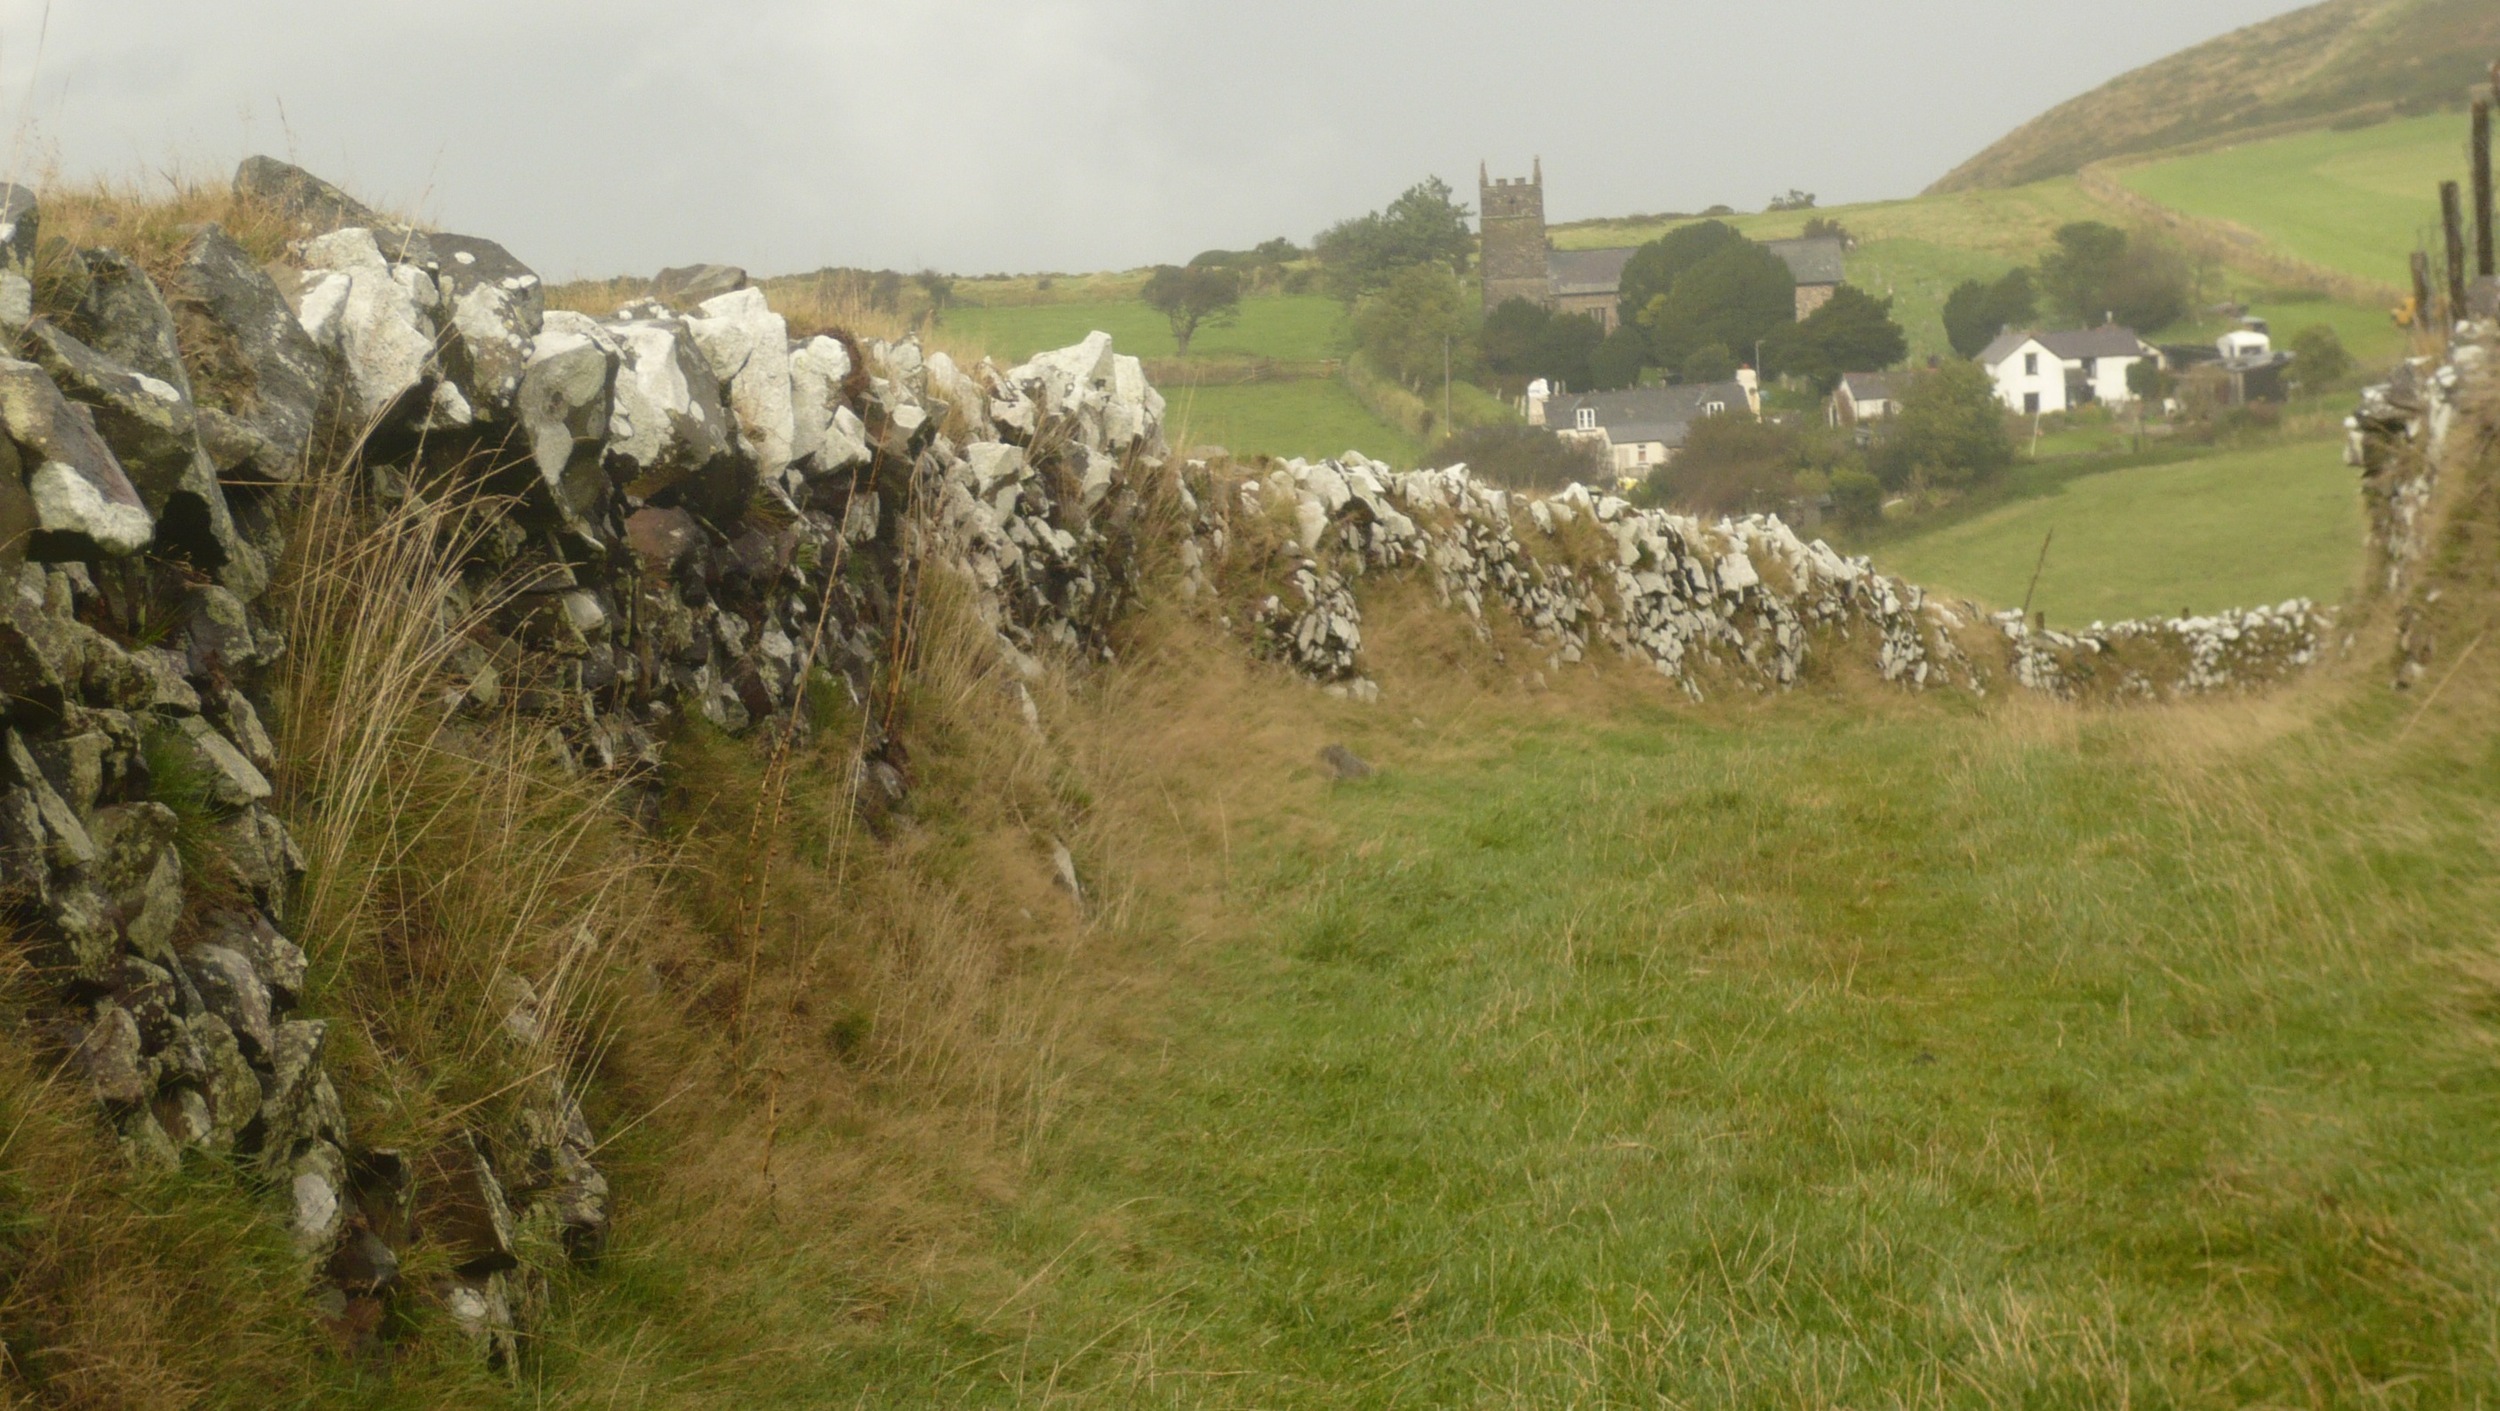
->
2118;113;2465;285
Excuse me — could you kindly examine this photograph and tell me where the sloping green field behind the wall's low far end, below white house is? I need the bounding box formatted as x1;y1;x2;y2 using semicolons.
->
1875;440;2363;628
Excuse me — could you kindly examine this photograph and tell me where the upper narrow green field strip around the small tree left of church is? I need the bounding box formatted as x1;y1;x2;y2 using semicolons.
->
945;295;1345;363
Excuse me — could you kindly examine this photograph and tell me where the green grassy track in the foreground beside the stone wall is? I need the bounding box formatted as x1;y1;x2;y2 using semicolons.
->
795;680;2500;1408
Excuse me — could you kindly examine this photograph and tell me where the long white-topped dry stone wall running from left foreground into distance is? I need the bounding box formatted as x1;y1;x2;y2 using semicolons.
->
0;158;2340;1358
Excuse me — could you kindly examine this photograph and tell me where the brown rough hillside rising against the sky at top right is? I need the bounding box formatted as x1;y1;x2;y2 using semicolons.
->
1928;0;2500;193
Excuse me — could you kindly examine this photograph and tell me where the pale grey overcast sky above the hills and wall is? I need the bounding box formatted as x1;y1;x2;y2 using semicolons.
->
0;0;2298;278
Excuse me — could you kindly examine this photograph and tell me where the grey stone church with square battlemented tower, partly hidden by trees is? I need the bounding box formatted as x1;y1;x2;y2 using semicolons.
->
1475;158;1848;333
